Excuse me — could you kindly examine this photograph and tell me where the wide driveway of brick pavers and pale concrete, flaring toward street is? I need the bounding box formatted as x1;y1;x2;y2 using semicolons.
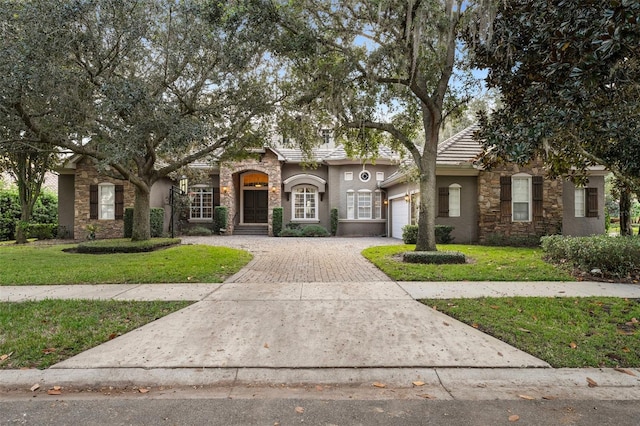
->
52;236;549;368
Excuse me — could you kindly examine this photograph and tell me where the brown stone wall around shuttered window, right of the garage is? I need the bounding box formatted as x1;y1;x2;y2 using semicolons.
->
478;162;563;242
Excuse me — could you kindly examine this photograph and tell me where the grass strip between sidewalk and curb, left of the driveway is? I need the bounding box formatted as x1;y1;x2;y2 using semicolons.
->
0;300;192;369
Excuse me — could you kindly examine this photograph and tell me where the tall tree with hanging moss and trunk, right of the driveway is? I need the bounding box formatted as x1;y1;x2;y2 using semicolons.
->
249;0;491;250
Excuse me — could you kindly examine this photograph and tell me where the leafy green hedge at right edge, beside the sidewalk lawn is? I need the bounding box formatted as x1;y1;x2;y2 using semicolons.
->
542;235;640;278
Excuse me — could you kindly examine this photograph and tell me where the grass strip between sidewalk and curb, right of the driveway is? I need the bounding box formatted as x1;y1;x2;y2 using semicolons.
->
421;297;640;368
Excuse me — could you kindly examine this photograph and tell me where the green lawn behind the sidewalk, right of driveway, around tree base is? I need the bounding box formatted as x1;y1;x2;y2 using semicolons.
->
362;244;575;281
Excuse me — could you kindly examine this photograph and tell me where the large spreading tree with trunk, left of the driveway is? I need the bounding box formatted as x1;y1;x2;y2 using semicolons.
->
0;0;277;239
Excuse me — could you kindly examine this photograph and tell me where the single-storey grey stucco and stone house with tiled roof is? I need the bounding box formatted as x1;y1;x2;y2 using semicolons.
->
58;126;606;243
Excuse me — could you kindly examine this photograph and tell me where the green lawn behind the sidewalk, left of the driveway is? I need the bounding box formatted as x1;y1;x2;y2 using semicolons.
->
0;244;252;285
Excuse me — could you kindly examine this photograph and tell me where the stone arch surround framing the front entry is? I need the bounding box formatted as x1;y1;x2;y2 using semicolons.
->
220;150;282;236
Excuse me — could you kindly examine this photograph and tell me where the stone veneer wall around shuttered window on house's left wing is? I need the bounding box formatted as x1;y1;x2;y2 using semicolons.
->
73;158;135;240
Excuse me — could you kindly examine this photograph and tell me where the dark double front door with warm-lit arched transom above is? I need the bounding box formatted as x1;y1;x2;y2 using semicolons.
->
240;171;269;224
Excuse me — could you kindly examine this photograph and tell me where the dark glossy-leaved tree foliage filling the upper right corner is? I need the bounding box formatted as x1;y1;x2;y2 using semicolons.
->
467;0;640;193
